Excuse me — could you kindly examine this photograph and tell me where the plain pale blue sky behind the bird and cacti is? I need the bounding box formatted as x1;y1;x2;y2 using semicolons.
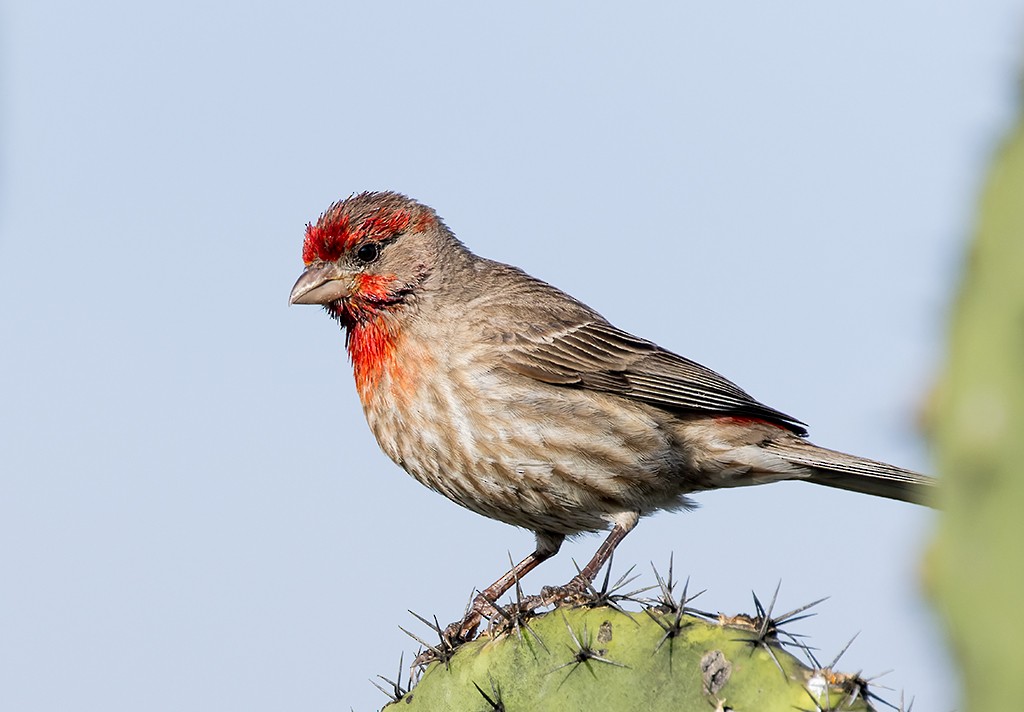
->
0;0;1024;712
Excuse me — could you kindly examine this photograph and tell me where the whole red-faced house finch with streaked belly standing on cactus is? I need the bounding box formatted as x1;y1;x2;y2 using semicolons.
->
290;193;934;639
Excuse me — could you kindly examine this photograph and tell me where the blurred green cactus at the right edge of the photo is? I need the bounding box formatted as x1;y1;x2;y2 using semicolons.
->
929;97;1024;710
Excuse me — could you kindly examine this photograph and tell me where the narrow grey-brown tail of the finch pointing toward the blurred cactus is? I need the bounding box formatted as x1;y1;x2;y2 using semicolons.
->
763;438;936;506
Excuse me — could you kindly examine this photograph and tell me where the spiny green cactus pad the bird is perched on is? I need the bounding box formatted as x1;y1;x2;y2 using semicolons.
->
385;606;871;712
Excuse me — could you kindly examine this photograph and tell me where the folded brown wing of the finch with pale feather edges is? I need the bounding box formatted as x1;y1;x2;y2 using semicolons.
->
497;321;805;434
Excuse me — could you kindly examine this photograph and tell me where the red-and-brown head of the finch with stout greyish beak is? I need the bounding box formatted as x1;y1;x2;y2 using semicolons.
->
289;193;448;328
